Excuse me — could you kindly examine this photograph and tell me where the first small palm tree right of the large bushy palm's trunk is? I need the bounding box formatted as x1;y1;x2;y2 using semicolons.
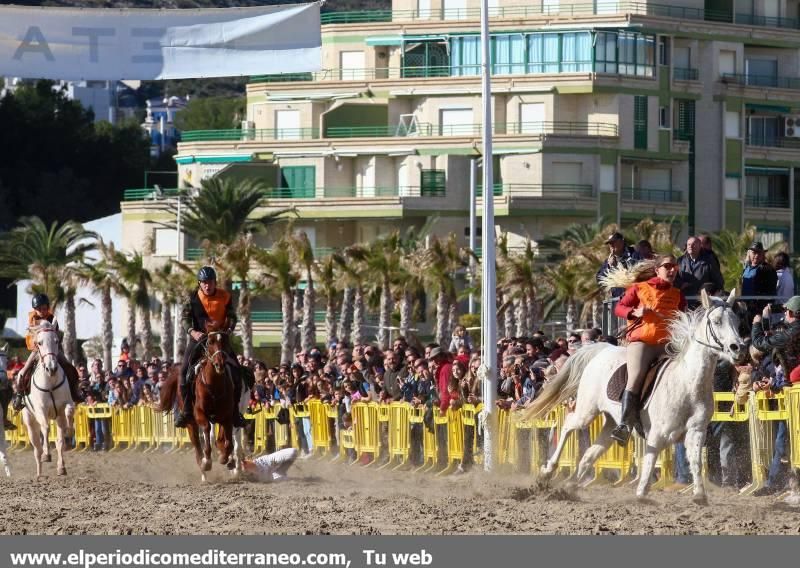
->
255;236;298;364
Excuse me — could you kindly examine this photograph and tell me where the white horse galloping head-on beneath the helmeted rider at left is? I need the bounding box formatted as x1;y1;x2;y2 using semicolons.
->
22;322;72;479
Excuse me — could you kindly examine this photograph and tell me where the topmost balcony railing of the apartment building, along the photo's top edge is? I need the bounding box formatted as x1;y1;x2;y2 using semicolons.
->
320;0;798;29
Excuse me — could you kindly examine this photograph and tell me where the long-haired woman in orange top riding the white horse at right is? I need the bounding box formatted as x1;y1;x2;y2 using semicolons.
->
611;255;686;445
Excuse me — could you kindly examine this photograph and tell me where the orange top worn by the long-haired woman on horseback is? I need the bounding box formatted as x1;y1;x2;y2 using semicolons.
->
614;277;686;345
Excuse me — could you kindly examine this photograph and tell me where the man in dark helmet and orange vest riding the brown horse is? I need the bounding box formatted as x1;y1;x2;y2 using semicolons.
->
175;266;244;428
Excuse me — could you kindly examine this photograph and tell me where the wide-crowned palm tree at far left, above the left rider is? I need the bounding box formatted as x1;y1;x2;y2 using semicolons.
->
0;217;97;361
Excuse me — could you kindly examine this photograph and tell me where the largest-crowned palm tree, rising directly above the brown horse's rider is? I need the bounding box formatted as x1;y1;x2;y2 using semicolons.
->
150;177;295;357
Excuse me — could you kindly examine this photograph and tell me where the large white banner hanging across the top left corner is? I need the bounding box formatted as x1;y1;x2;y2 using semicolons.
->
0;3;322;80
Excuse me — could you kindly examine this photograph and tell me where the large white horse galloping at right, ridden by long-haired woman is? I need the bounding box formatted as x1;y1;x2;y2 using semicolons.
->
525;290;744;504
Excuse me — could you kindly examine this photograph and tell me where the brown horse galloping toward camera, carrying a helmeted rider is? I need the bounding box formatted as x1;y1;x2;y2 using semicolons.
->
159;331;236;481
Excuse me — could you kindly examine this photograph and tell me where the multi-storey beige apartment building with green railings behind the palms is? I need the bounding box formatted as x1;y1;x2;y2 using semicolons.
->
122;0;800;346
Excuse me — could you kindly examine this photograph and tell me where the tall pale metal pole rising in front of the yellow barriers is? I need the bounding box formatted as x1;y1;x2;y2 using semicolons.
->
481;0;497;471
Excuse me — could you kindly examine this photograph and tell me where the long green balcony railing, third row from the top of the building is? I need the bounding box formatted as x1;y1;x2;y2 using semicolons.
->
182;121;619;142
